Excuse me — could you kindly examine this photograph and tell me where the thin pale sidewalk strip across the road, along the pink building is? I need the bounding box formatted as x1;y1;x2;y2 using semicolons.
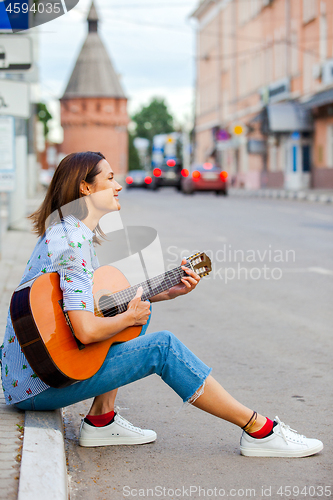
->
229;187;333;203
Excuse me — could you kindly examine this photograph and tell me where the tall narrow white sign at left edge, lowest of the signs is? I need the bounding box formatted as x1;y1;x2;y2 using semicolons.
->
0;116;15;192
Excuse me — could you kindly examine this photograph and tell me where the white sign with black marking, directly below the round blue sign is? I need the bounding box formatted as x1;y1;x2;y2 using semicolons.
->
0;35;32;73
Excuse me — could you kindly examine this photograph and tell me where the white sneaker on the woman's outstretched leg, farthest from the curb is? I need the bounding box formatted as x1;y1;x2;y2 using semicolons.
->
240;417;324;458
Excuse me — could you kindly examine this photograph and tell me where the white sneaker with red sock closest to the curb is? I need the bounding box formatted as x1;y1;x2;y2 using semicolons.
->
79;413;157;446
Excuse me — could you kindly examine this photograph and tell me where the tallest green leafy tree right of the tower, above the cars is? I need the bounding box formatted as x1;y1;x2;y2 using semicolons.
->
132;97;174;146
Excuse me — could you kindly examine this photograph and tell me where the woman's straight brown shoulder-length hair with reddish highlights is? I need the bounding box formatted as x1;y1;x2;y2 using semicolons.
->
28;151;105;241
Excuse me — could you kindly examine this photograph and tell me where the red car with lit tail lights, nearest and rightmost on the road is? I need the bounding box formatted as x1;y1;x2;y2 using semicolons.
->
181;163;228;195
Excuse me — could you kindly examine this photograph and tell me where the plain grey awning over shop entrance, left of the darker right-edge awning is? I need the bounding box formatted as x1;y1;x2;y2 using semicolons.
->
263;102;313;133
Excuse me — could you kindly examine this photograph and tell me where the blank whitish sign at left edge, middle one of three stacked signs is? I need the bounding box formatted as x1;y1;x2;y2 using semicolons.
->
0;80;30;118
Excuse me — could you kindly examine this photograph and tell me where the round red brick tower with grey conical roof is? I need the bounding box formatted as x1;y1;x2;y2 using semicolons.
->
60;2;129;176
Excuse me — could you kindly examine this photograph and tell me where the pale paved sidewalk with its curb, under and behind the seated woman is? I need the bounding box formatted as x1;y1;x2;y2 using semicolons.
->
0;199;67;500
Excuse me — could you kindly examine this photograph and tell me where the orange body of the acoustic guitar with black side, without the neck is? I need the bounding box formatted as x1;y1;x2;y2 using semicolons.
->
11;266;146;388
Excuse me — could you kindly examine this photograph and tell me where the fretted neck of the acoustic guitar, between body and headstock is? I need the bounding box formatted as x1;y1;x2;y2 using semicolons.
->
112;262;191;312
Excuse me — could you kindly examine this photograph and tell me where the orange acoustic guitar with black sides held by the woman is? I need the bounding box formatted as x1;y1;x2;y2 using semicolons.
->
10;253;211;388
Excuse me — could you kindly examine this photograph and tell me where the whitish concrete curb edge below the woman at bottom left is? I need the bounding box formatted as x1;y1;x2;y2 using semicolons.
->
18;410;68;500
